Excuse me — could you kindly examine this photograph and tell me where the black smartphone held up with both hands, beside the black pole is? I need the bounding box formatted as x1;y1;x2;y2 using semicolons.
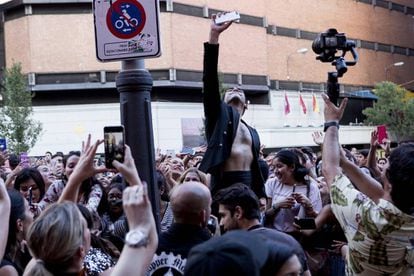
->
104;126;125;169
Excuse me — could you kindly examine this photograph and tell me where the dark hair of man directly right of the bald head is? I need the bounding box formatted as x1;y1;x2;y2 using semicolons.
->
214;183;260;220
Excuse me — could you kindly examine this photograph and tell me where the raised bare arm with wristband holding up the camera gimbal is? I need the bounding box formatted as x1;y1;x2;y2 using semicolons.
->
322;93;348;187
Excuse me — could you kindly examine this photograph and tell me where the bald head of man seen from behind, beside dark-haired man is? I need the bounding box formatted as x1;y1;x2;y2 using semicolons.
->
170;182;211;226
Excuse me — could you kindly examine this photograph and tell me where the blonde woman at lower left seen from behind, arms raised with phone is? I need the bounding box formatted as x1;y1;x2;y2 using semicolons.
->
24;136;158;276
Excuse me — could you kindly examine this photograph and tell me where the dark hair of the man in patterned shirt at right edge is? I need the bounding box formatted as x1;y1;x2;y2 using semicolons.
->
386;143;414;215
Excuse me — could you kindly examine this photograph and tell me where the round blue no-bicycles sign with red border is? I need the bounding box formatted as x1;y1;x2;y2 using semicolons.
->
106;0;146;39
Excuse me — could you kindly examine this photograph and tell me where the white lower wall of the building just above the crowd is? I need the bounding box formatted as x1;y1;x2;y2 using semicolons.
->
30;91;371;155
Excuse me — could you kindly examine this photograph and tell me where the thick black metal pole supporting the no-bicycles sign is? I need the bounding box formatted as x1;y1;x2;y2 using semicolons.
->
116;59;160;231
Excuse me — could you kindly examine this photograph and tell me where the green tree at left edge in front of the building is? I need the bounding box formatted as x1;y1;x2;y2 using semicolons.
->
0;63;42;153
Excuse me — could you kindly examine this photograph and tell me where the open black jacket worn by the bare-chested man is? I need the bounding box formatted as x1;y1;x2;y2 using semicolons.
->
200;43;266;198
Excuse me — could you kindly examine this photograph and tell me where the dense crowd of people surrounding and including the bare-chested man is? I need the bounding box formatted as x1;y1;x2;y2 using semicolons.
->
0;13;414;276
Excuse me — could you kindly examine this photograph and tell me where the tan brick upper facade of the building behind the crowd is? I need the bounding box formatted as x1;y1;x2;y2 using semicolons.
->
5;0;414;86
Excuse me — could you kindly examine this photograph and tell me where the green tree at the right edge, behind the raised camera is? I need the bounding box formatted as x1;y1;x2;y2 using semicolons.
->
363;82;414;143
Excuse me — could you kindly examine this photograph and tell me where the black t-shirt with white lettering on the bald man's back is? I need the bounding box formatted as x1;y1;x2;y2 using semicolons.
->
147;223;211;276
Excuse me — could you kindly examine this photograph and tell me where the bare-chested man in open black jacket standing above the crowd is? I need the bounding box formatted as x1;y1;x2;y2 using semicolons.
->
200;15;266;201
